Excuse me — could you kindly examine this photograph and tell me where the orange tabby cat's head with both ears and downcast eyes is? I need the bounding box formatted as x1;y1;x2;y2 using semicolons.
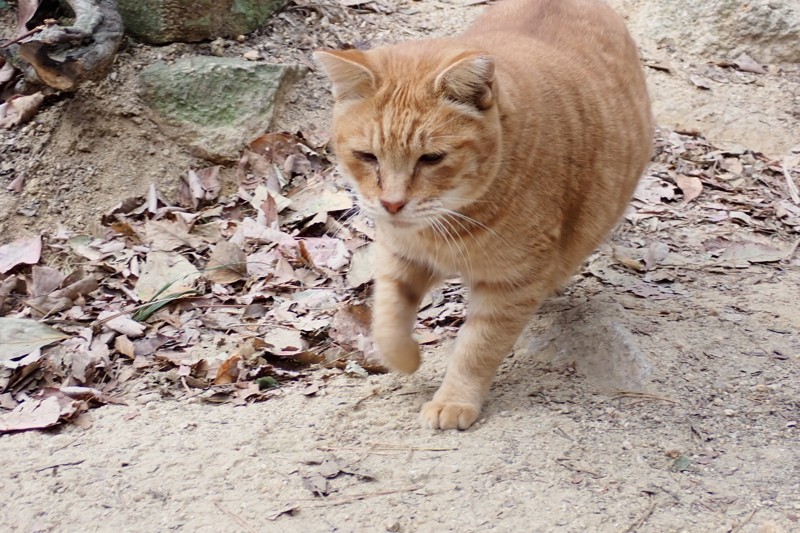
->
315;41;501;228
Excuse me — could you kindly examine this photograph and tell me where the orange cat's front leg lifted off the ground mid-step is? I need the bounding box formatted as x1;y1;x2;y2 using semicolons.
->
372;246;438;374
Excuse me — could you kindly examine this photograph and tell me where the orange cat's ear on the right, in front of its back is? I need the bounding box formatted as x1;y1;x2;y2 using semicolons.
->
433;53;494;110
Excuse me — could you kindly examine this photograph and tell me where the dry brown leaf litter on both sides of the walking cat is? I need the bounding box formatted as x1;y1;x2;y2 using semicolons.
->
0;130;800;432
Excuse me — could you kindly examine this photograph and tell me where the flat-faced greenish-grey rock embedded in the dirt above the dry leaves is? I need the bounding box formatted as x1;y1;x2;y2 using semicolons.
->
139;56;306;161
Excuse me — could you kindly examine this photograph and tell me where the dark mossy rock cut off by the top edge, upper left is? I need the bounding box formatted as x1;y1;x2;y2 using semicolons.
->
117;0;287;44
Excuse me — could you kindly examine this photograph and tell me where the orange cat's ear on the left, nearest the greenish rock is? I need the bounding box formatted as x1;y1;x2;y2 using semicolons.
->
314;50;375;101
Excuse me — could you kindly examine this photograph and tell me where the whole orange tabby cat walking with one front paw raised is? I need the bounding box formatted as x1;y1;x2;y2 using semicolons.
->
315;0;652;429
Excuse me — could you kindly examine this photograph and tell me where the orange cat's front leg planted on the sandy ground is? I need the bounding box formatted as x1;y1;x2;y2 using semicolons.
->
420;283;539;429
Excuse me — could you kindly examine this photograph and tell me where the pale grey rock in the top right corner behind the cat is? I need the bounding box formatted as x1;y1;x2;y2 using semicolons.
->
616;0;800;63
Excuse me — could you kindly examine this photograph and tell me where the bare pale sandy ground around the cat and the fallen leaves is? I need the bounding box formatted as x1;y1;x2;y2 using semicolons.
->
0;2;800;533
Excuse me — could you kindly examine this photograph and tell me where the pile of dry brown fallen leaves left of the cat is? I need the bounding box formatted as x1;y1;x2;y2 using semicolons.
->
0;129;463;432
